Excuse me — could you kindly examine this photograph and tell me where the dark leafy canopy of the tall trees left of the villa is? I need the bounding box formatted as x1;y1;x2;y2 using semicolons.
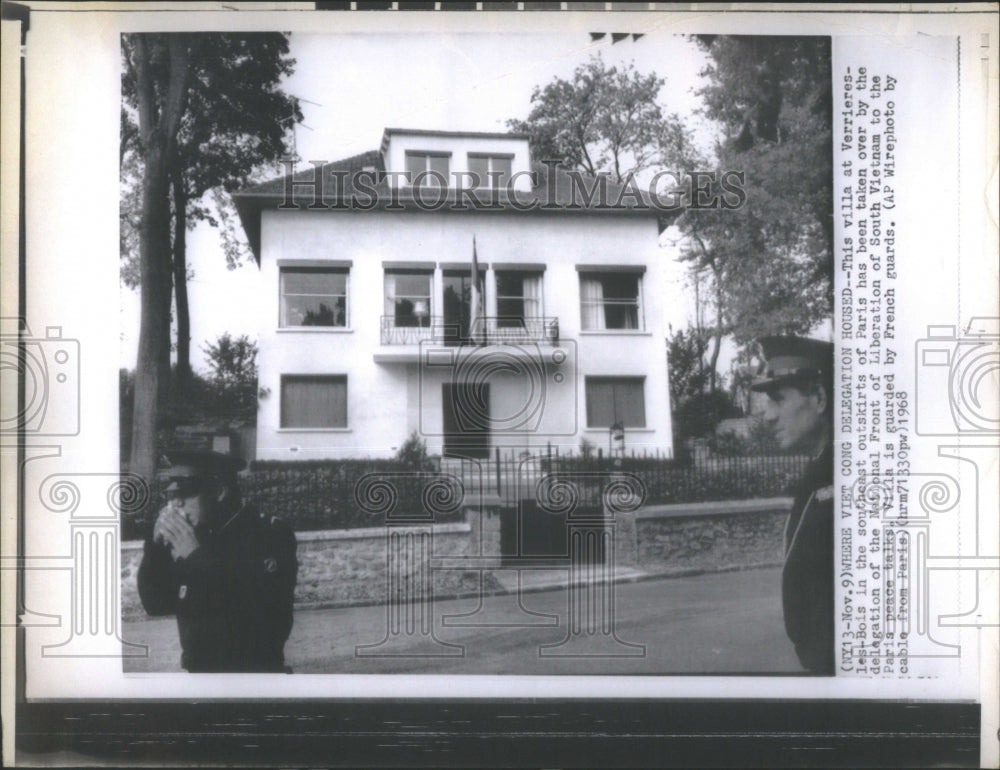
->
120;33;302;288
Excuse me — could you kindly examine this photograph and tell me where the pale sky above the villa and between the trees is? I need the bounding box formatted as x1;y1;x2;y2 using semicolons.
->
120;31;711;372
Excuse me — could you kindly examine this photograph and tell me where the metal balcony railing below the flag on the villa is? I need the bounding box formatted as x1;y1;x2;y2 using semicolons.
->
382;315;559;345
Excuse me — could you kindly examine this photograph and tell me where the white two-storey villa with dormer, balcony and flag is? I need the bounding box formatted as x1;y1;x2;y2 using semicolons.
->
234;128;672;460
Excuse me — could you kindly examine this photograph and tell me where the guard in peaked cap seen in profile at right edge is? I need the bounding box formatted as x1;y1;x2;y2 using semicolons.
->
751;337;834;675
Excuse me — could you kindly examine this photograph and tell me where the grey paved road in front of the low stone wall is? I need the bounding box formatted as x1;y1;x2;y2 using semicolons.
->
123;568;801;674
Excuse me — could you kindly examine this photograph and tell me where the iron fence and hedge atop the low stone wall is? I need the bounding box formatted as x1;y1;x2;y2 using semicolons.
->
122;450;809;539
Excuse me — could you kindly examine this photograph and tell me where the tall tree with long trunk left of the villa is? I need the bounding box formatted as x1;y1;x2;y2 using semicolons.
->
121;34;301;478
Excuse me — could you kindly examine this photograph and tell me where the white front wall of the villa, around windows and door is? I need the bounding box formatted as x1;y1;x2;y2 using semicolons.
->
257;211;672;459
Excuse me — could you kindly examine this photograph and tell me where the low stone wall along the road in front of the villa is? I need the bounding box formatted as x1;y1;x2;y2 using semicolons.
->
121;498;791;619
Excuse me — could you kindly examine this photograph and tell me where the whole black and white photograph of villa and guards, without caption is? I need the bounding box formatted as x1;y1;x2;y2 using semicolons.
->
113;32;834;675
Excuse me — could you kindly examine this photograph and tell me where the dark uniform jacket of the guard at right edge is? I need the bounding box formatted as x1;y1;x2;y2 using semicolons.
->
781;446;834;674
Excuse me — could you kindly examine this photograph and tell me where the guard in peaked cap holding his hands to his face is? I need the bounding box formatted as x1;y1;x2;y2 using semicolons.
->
138;452;298;673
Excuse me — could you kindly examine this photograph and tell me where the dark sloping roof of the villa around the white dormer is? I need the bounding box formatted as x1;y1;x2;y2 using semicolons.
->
233;147;680;263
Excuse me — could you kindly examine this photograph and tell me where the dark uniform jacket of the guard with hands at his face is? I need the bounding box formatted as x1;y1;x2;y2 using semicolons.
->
138;506;298;672
